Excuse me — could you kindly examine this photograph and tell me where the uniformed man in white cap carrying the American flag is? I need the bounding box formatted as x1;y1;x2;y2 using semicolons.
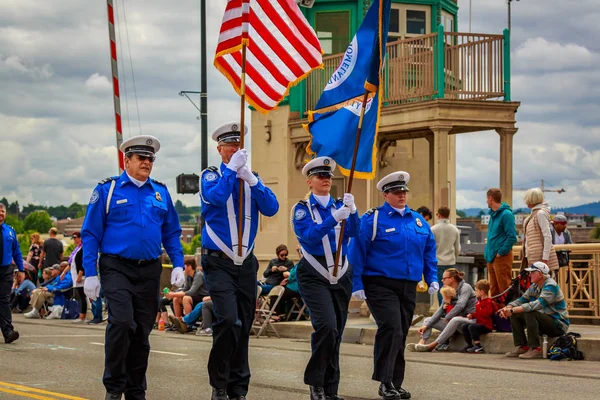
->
200;122;279;400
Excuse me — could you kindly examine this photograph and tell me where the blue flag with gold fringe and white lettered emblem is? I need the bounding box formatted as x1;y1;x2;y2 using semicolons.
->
305;0;391;179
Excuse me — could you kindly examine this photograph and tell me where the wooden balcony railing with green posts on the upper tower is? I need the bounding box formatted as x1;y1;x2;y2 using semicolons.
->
302;26;510;113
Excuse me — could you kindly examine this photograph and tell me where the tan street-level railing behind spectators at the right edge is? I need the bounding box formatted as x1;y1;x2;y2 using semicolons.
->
513;243;600;322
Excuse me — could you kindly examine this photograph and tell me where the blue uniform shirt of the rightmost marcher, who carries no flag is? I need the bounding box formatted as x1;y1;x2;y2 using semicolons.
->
348;203;437;291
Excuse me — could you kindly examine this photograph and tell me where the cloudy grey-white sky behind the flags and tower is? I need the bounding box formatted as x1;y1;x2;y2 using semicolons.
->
0;0;600;208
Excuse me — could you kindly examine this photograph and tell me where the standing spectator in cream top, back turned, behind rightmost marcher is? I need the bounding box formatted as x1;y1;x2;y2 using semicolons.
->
431;207;460;304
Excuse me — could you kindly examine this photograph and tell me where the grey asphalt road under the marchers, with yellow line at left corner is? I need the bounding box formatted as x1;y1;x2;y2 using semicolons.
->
0;316;600;400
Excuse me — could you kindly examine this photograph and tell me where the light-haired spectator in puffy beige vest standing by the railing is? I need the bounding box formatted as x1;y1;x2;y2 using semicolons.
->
523;188;558;273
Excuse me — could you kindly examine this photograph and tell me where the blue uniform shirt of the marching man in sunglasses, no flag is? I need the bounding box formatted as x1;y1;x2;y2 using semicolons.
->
81;172;183;277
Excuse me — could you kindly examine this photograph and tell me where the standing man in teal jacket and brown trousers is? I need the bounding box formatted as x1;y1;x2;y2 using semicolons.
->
483;188;517;297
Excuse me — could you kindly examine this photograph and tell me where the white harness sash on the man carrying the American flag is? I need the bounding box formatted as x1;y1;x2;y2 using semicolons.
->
205;169;254;265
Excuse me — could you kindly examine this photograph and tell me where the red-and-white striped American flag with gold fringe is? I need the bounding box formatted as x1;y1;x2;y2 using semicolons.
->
214;0;323;113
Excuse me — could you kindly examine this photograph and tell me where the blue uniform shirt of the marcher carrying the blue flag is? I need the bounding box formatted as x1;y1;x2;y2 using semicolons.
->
292;194;360;256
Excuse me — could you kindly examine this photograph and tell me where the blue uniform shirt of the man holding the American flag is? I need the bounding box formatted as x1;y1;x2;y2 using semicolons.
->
200;163;279;250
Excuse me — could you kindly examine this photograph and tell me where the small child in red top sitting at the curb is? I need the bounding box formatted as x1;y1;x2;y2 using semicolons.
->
461;279;497;353
